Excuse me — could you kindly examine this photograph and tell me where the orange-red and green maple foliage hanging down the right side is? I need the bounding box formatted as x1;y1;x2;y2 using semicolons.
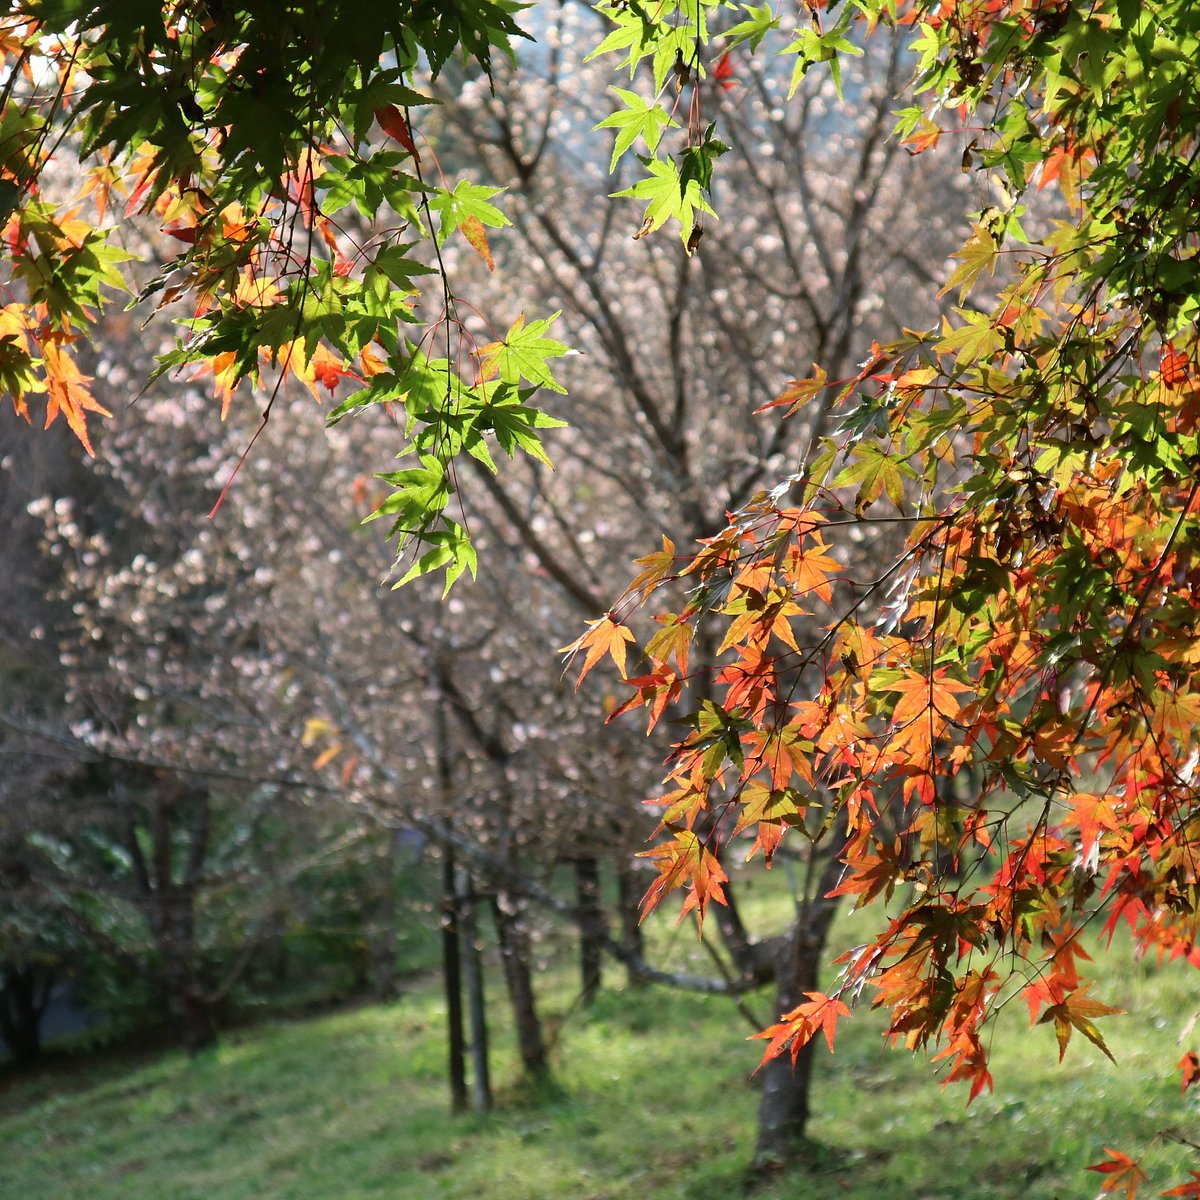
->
572;0;1200;1198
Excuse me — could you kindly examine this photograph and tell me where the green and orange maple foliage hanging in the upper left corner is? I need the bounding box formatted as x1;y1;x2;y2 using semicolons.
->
0;0;565;582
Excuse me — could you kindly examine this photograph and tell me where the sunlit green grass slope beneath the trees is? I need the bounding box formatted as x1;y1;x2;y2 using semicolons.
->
0;902;1200;1200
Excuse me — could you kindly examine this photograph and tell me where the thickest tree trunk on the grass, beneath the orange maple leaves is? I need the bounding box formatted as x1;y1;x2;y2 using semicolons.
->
754;898;838;1170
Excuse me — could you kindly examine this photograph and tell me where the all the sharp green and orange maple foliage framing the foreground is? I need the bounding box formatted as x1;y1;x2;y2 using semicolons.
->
7;0;1200;1196
